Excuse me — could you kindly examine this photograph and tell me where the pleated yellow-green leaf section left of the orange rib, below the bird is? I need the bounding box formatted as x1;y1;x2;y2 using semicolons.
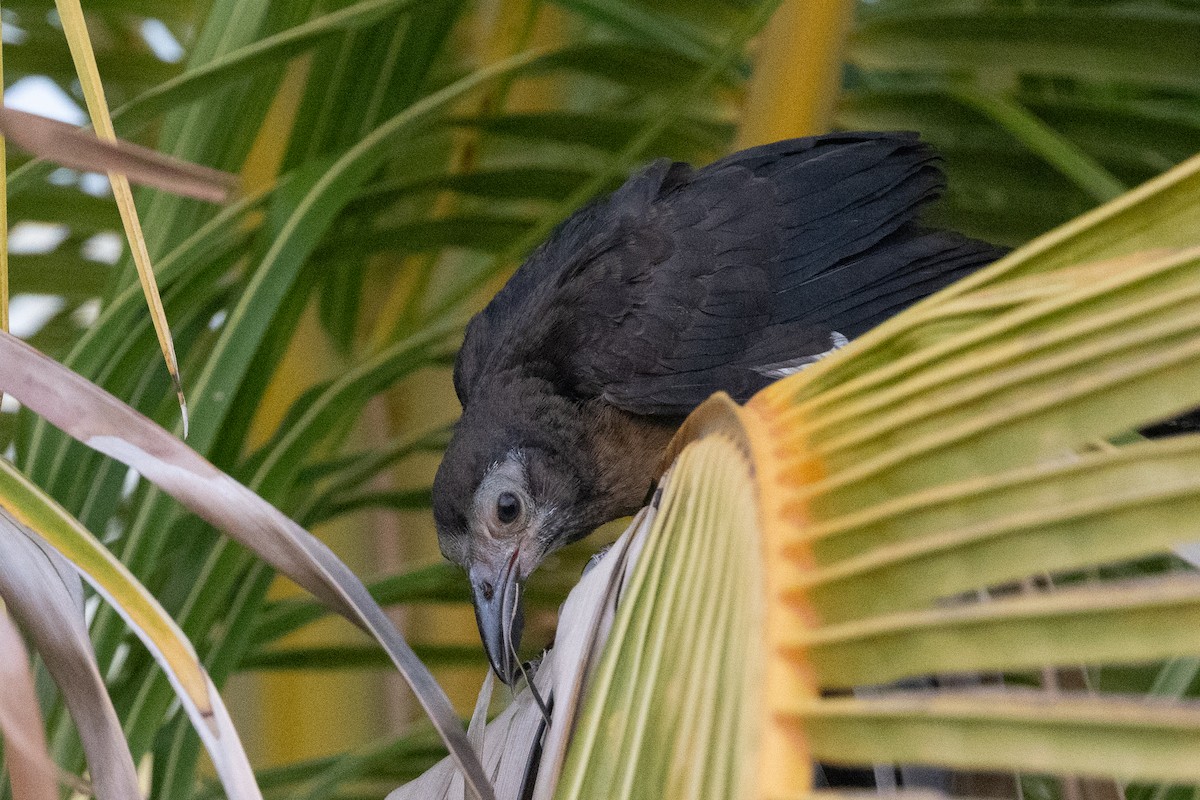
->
554;417;763;799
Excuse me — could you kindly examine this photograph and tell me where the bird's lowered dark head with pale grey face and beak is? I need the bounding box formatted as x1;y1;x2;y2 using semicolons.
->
433;379;605;685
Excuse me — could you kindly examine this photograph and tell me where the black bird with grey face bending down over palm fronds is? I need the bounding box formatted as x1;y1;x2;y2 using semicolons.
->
433;133;1003;684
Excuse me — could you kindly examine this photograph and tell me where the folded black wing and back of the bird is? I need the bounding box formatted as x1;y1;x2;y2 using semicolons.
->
456;133;1001;415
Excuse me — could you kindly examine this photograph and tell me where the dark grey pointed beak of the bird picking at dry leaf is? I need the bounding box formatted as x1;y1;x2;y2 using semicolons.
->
470;549;524;686
